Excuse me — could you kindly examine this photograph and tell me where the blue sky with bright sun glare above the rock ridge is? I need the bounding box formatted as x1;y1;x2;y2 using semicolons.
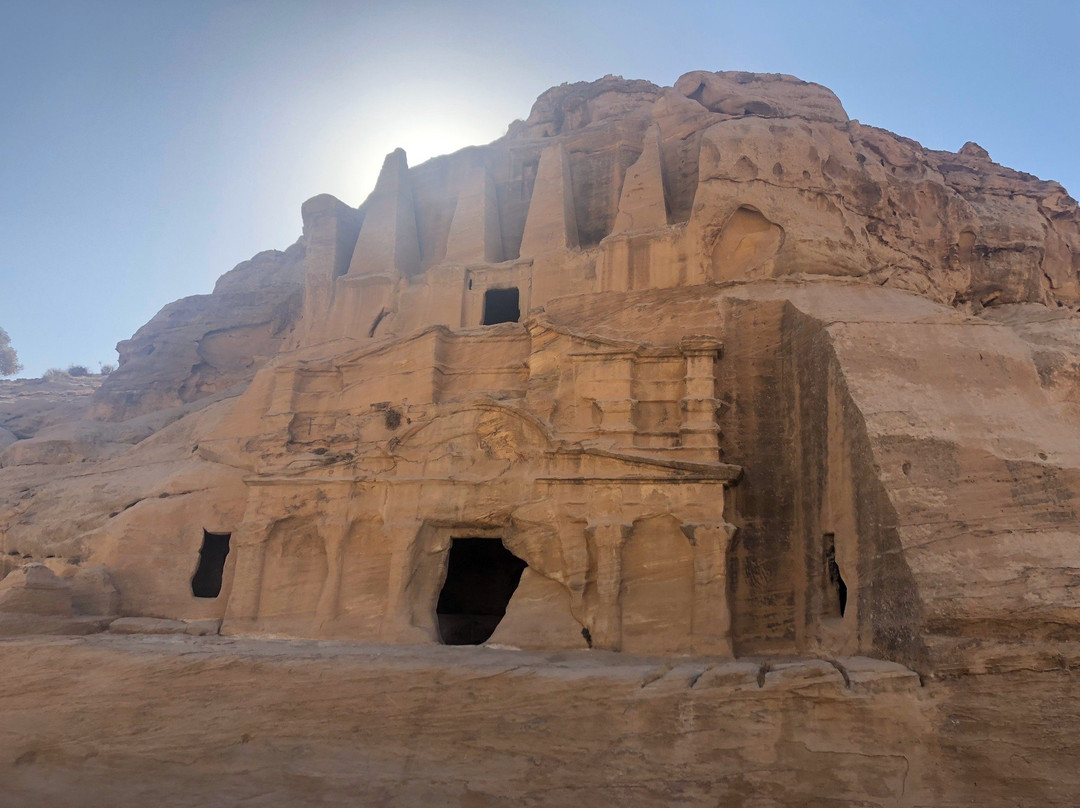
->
0;0;1080;376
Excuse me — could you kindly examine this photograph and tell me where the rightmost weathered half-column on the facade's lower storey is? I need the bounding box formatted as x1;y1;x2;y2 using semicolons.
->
683;522;735;656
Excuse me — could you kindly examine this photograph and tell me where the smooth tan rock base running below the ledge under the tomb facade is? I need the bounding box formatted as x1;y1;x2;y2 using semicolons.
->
0;635;1080;808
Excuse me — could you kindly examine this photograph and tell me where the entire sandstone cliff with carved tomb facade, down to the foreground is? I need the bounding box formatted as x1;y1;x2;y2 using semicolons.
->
0;72;1080;806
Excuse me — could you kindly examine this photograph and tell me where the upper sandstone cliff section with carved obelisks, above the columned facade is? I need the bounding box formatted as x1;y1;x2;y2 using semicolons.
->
302;72;1080;356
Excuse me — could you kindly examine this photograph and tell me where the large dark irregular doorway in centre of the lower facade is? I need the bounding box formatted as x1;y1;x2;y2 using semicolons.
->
435;538;526;645
